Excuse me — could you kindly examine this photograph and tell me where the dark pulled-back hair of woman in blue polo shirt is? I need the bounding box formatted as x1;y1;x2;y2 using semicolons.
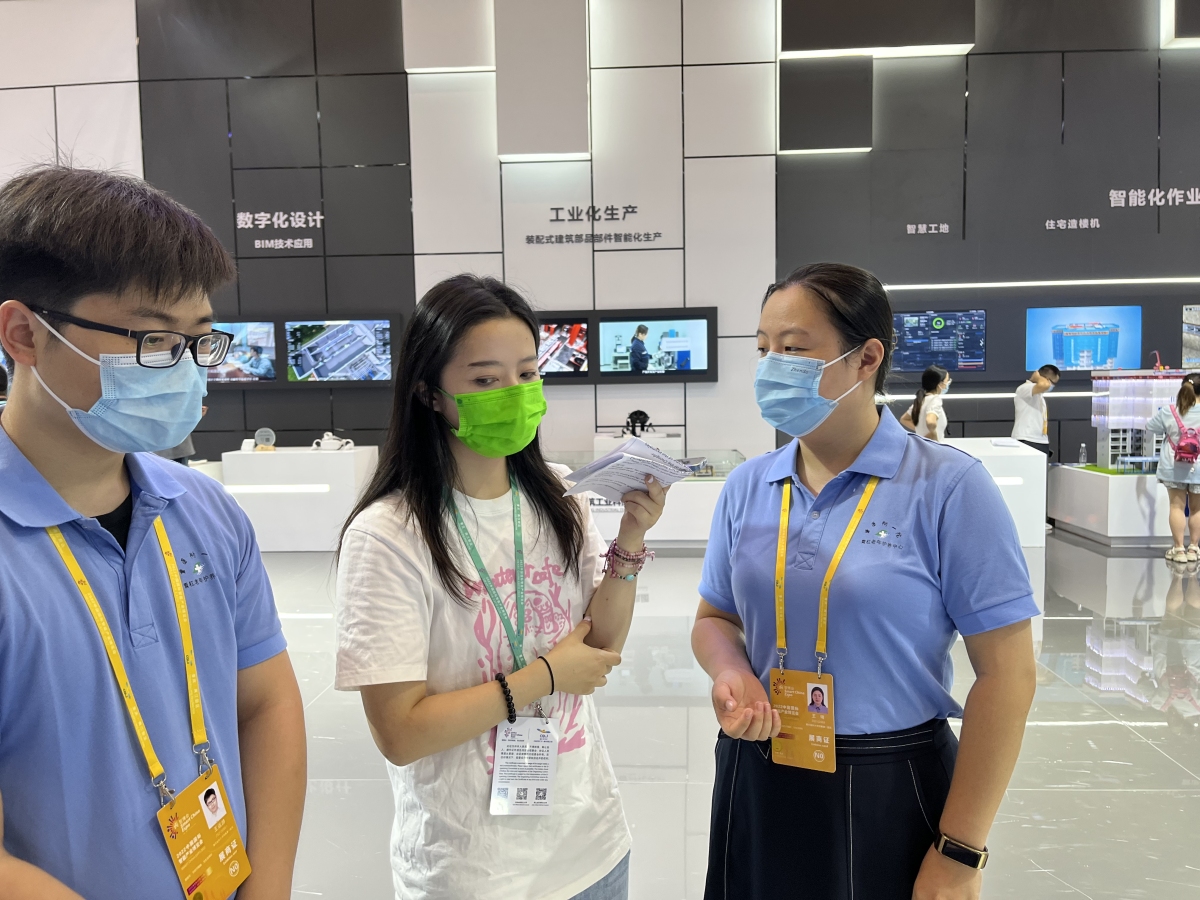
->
762;263;895;394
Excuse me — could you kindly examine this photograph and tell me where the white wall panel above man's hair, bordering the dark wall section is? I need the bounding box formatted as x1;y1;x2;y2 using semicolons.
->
55;82;142;178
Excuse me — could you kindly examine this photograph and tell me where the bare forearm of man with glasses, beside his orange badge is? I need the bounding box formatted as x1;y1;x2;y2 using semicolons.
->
238;690;308;900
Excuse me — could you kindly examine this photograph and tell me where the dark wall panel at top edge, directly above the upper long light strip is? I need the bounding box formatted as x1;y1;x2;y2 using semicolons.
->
780;0;976;50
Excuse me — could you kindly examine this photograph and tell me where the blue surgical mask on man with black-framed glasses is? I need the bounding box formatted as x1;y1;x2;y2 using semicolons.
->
32;316;208;454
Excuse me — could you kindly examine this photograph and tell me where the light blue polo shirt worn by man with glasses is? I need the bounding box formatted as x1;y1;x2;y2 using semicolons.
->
0;427;286;900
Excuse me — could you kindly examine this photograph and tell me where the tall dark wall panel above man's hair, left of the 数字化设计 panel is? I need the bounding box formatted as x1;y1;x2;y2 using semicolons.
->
142;82;234;252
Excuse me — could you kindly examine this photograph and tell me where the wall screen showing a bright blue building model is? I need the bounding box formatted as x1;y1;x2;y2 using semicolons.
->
1025;306;1141;372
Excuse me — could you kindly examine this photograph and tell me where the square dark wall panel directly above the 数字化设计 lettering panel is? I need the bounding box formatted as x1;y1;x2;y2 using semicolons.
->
229;78;320;168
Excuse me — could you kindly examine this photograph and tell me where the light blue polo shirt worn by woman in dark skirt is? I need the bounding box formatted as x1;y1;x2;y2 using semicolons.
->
700;408;1038;734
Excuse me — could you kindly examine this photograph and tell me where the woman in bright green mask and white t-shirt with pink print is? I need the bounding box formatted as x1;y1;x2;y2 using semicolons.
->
335;275;665;900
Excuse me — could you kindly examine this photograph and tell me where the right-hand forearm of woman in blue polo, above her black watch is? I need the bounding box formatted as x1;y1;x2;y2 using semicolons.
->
941;673;1036;848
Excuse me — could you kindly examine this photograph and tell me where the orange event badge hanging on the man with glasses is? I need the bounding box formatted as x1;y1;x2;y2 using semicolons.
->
158;766;250;900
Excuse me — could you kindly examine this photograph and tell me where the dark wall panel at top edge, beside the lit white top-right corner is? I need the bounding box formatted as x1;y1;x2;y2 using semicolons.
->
974;0;1158;53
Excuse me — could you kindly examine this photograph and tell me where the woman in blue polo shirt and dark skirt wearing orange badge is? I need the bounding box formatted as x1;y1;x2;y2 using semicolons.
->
692;264;1038;900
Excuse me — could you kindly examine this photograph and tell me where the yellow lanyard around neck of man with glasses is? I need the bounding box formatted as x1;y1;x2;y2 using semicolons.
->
46;517;212;803
